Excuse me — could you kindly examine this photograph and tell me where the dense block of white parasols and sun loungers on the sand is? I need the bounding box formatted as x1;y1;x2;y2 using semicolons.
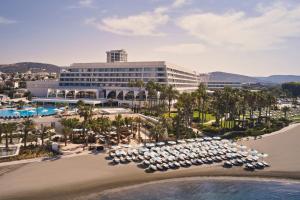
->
108;137;269;172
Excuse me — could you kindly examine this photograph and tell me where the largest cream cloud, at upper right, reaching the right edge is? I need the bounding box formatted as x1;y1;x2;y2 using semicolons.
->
177;4;300;50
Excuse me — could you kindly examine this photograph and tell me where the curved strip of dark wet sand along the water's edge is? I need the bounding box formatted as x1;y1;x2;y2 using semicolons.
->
0;167;300;200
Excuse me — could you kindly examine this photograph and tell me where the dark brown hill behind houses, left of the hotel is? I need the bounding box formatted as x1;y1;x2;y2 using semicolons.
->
0;62;60;73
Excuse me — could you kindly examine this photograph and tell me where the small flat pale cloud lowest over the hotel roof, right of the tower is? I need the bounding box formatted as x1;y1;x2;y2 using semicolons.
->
155;43;206;55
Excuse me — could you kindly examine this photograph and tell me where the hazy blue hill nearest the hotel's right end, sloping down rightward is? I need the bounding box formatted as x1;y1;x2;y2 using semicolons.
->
209;72;259;83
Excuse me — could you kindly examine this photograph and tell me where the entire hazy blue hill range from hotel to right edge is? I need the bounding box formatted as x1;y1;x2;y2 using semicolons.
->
209;72;300;84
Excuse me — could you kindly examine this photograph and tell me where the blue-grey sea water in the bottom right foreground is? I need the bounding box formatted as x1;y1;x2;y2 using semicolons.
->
93;179;300;200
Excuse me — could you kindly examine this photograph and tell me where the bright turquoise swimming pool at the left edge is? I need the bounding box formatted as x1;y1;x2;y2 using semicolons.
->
0;107;60;118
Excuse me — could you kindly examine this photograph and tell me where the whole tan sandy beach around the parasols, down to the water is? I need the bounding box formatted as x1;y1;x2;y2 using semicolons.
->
0;124;300;199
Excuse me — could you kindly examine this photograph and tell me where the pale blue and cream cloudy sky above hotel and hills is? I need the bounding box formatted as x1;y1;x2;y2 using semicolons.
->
0;0;300;76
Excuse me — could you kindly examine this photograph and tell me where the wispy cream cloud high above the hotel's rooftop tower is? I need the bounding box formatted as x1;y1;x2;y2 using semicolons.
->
85;10;169;36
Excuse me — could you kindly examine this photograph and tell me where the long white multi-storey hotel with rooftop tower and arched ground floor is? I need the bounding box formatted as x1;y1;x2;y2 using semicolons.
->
27;50;199;104
